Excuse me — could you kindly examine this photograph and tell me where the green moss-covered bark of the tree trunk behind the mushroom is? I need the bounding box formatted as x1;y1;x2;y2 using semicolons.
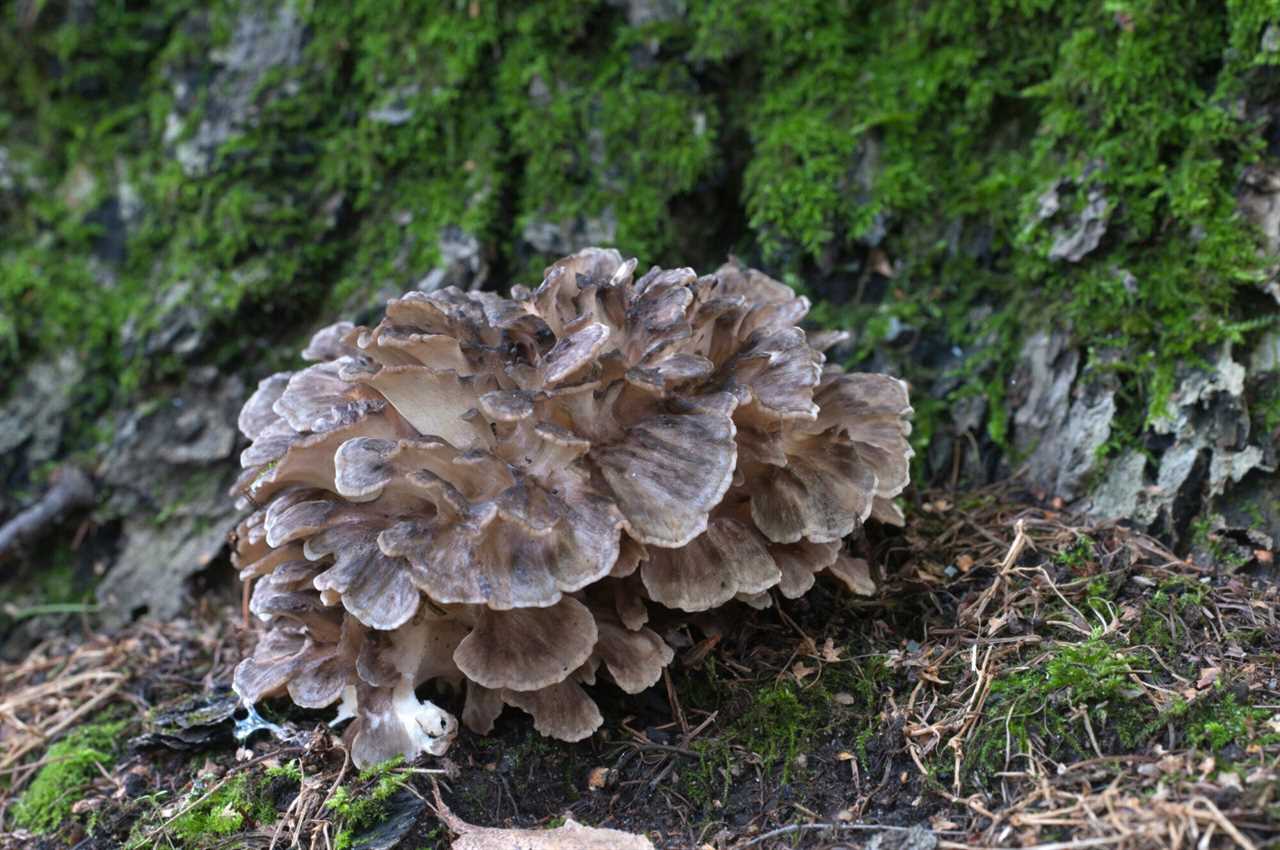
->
0;0;1280;478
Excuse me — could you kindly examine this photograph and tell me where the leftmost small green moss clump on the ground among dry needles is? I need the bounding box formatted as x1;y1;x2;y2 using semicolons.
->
13;719;128;833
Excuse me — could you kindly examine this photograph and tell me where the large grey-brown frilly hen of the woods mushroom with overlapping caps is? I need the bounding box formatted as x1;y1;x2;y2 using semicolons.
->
227;250;911;766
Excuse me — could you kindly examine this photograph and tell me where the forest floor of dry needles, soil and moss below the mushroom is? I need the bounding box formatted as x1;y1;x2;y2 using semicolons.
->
0;485;1280;850
